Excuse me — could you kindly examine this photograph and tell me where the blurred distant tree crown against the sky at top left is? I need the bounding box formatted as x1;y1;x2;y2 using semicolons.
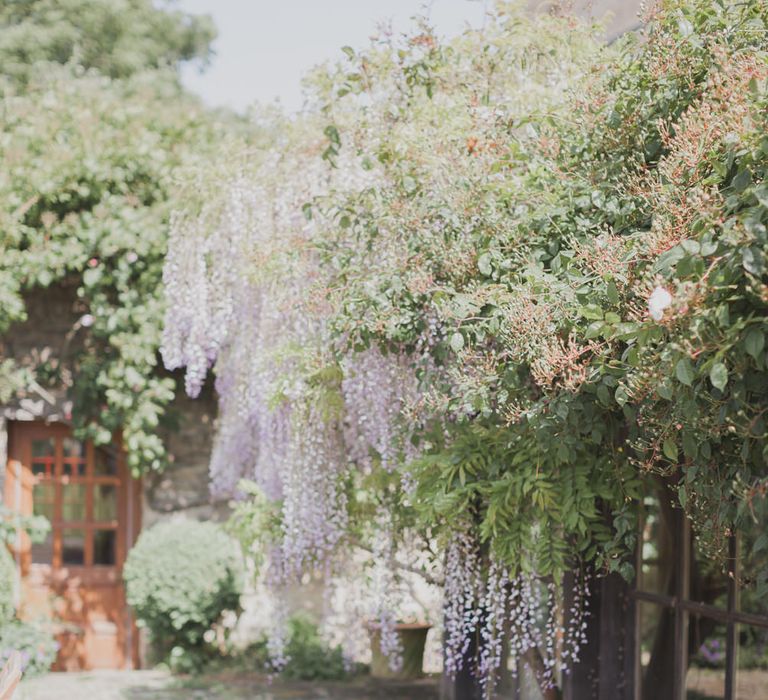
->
0;0;215;82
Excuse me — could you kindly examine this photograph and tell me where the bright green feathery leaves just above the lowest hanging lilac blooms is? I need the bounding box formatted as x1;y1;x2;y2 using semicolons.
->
412;422;641;576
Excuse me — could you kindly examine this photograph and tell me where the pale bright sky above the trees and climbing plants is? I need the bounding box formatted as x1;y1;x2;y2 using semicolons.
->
178;0;490;111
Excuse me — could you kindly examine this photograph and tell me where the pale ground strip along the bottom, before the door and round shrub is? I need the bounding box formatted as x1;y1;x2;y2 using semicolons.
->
14;671;437;700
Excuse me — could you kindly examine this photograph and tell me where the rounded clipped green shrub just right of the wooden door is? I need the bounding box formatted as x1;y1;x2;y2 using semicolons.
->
123;520;242;661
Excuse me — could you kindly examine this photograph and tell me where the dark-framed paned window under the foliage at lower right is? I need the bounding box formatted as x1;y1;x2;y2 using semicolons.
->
632;484;768;700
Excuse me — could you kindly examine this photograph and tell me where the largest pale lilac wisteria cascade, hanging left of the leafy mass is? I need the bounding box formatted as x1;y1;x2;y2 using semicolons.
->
162;146;396;667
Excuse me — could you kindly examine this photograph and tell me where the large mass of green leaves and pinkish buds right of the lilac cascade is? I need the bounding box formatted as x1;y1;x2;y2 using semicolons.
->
313;0;768;577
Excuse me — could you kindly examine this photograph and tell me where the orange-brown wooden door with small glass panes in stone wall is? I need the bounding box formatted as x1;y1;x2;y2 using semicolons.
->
5;422;140;671
